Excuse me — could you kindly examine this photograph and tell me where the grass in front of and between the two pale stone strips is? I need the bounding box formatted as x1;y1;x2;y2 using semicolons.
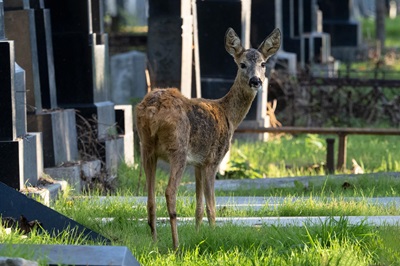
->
0;184;400;265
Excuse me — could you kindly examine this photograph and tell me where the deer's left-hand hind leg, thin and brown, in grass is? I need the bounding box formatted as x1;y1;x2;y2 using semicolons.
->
141;147;157;241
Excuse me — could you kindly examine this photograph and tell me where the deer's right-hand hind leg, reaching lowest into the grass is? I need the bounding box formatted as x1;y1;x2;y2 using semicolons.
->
165;154;186;249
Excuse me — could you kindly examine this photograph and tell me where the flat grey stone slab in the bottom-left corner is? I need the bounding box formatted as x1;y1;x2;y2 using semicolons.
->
0;244;140;266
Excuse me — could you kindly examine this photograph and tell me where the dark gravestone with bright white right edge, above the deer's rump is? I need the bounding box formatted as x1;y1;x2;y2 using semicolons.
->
147;0;193;98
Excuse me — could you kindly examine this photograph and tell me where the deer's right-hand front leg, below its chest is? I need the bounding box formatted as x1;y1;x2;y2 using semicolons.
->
203;165;218;226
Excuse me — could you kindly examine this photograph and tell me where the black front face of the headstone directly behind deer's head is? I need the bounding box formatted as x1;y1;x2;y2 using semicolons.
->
196;0;265;120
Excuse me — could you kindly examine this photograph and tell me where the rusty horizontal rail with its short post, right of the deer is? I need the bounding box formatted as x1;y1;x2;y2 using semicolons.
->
235;127;400;169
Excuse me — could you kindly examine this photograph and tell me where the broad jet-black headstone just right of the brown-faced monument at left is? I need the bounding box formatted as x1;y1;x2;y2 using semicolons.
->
45;0;108;109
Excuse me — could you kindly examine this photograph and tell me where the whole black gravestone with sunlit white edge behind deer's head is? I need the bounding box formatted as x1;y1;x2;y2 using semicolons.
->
197;0;268;140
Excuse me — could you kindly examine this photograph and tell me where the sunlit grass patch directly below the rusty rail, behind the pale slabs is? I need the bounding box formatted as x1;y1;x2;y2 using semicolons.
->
227;134;400;178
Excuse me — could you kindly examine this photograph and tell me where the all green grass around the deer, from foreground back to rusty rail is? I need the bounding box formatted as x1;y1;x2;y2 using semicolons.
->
0;135;400;265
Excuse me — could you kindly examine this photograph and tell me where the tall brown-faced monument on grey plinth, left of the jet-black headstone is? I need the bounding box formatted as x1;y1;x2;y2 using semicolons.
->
4;0;78;167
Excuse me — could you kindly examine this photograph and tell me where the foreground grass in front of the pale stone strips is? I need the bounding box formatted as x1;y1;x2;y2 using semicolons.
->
0;206;400;265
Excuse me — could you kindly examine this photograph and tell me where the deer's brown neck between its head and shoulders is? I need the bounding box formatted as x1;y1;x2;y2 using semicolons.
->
221;78;257;129
